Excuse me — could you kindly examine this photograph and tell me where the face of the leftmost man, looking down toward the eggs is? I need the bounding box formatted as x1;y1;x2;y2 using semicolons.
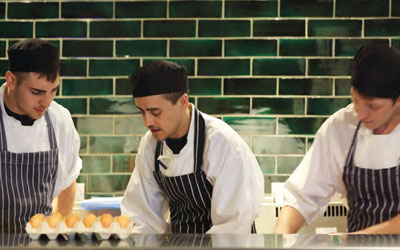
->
7;72;60;119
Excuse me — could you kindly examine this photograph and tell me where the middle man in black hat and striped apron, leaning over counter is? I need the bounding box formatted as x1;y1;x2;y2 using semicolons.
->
121;61;264;233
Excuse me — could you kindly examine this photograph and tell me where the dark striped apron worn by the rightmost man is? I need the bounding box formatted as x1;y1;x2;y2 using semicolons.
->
343;122;400;232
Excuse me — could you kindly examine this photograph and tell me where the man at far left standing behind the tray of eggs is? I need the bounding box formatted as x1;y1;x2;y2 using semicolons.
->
0;39;82;233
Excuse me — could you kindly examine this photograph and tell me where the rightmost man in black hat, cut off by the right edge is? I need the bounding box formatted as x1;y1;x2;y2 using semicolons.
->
275;45;400;234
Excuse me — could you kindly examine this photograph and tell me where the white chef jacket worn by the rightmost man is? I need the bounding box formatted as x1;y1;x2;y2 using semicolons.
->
284;104;400;224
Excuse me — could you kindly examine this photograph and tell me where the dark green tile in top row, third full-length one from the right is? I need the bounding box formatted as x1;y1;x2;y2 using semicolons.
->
225;0;278;17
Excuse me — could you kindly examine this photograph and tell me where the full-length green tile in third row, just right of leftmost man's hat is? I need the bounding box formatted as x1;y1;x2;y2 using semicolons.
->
62;40;113;57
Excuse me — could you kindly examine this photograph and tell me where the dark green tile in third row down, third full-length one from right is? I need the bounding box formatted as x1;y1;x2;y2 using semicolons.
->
225;39;277;56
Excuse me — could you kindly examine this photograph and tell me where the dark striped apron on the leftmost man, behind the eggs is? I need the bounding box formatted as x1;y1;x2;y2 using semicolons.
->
0;109;58;233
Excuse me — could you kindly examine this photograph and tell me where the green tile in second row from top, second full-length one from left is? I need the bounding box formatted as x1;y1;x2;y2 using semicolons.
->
90;21;140;38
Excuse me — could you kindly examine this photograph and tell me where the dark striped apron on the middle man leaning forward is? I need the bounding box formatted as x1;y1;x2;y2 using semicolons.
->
154;107;255;234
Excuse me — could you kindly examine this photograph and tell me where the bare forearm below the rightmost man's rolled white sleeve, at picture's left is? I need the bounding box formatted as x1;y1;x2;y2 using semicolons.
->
274;206;305;234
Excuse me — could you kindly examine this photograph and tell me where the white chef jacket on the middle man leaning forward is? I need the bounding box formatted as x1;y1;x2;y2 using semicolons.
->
121;104;264;233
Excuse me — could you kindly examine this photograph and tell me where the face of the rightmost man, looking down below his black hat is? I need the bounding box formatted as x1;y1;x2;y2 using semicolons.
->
351;88;400;130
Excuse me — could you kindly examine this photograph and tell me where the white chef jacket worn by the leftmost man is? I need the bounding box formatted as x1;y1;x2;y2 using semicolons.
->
0;84;82;198
